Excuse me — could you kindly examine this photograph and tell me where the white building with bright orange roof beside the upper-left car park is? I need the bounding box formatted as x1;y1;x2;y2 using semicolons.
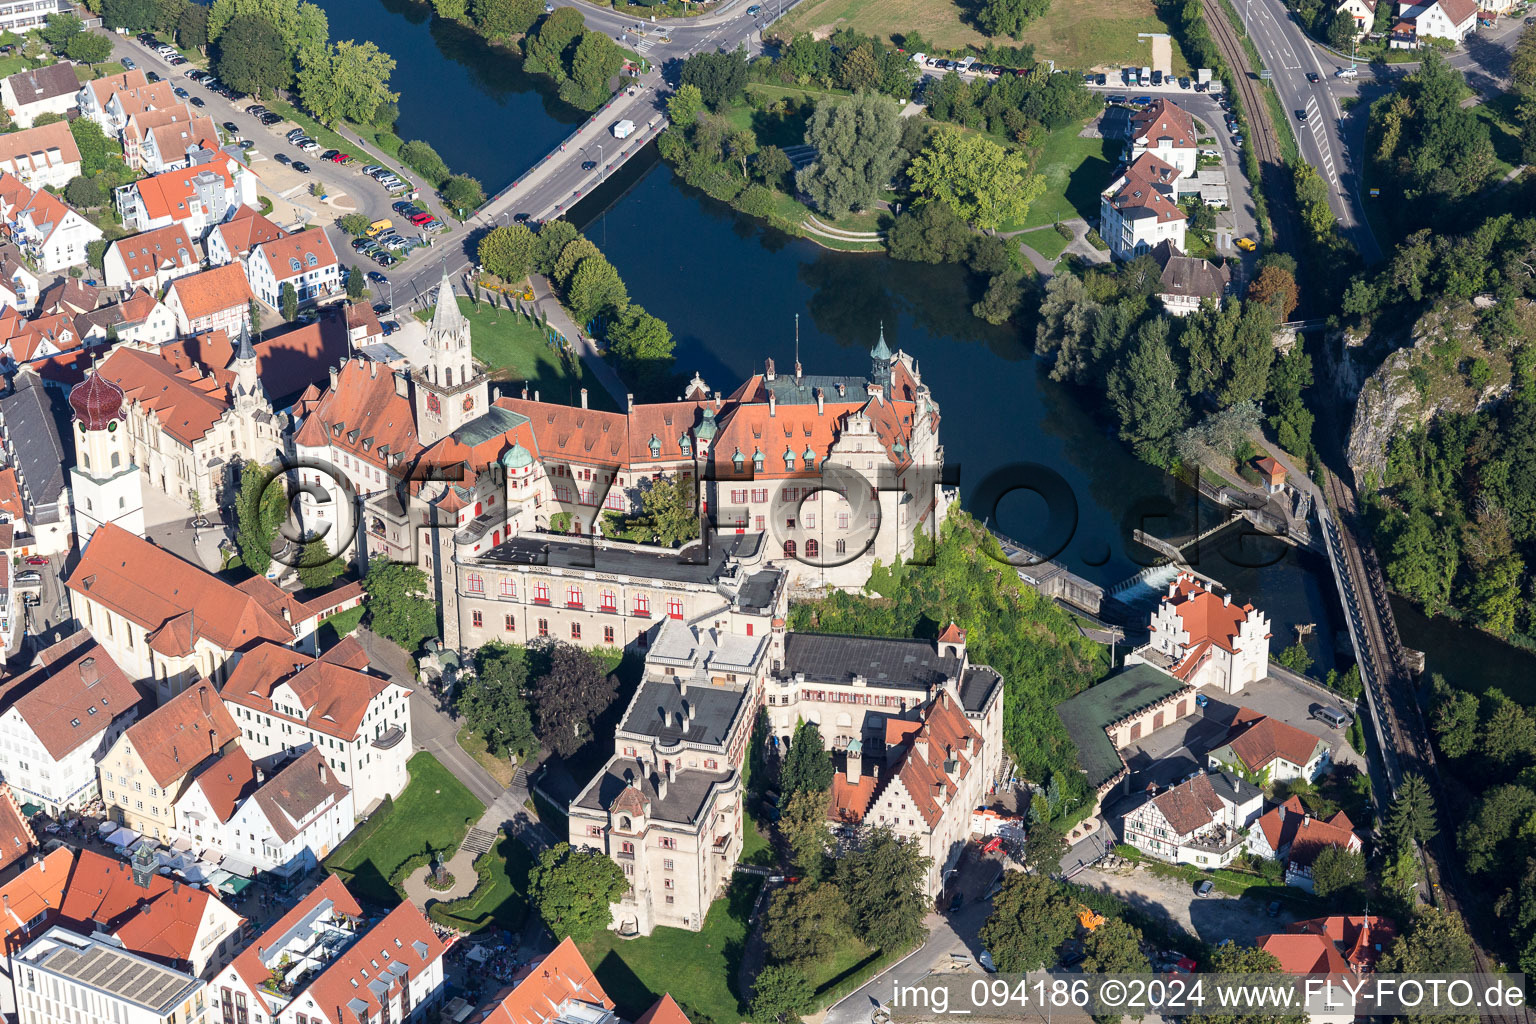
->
115;152;257;241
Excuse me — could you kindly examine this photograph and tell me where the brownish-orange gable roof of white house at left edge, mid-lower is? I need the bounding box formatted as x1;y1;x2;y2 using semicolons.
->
0;629;138;761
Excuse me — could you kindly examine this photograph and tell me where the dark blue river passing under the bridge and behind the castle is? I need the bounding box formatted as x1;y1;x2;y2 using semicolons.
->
308;0;1536;687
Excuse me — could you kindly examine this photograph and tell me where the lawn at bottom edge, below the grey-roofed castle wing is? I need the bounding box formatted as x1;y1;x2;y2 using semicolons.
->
581;875;762;1024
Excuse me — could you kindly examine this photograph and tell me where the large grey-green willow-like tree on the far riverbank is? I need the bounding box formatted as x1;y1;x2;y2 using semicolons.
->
796;92;902;220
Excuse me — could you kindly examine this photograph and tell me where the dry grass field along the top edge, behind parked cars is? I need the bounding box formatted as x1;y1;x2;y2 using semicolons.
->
774;0;1189;74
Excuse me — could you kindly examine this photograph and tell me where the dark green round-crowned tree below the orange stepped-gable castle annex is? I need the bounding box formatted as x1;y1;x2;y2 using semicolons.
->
837;824;932;952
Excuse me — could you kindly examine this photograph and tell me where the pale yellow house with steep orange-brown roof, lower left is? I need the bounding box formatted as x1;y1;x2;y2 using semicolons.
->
100;679;240;843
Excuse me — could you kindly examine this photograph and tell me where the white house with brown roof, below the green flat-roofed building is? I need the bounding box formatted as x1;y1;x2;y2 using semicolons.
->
1123;771;1264;869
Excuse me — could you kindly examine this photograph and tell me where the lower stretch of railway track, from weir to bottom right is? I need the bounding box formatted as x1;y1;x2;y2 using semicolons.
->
1318;473;1530;1024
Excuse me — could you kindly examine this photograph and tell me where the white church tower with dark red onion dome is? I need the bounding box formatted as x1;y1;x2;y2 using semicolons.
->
69;372;144;547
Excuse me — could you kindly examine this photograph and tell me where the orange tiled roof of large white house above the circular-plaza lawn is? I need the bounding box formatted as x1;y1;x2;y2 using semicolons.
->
224;637;409;740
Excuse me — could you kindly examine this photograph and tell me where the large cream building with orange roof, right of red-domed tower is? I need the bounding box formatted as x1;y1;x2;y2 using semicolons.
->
77;334;283;508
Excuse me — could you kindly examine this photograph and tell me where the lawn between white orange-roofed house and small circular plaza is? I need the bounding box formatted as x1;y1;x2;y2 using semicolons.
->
326;751;485;906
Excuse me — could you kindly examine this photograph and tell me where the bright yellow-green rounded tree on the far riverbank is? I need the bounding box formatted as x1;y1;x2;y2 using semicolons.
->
908;126;1046;230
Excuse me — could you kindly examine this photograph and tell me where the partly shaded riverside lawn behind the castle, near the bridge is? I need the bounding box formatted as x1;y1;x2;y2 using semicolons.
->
416;292;614;410
